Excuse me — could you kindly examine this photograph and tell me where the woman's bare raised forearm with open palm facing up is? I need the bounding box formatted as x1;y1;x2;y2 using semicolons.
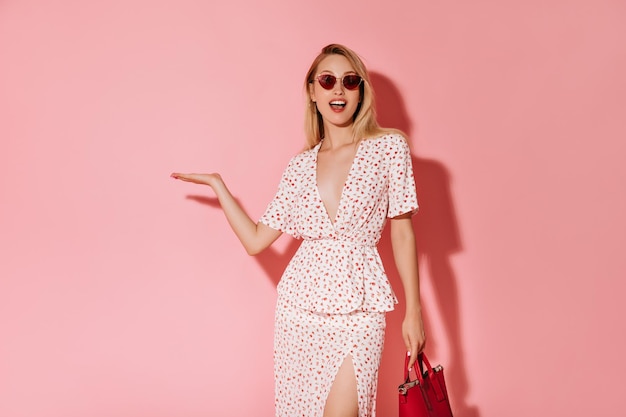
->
171;172;281;255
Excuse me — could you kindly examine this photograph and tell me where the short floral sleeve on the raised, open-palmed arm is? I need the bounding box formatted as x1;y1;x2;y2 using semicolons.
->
259;159;298;237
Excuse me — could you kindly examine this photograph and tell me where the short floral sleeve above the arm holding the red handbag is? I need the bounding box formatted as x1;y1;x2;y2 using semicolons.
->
387;135;418;218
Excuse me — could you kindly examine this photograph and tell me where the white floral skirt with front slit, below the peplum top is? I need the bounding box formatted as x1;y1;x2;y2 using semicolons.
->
274;296;385;417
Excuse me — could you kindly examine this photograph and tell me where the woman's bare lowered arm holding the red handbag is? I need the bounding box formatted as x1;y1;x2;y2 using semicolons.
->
390;213;426;368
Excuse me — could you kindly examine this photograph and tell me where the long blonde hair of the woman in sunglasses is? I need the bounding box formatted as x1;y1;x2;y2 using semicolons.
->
304;44;405;149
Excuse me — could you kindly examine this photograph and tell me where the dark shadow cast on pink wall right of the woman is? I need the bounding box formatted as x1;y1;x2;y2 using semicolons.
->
370;72;479;417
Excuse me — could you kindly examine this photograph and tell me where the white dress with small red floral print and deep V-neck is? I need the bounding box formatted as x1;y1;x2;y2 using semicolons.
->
260;134;418;417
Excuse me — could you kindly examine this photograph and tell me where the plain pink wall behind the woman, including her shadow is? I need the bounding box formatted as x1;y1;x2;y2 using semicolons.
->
0;0;626;417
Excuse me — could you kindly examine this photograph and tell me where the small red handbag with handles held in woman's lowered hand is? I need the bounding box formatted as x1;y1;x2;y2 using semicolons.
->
398;353;452;417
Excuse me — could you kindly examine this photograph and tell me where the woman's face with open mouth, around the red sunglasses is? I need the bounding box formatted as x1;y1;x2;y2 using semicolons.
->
309;55;361;127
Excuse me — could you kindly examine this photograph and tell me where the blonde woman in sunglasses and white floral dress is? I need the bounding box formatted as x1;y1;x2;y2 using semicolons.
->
172;44;425;417
